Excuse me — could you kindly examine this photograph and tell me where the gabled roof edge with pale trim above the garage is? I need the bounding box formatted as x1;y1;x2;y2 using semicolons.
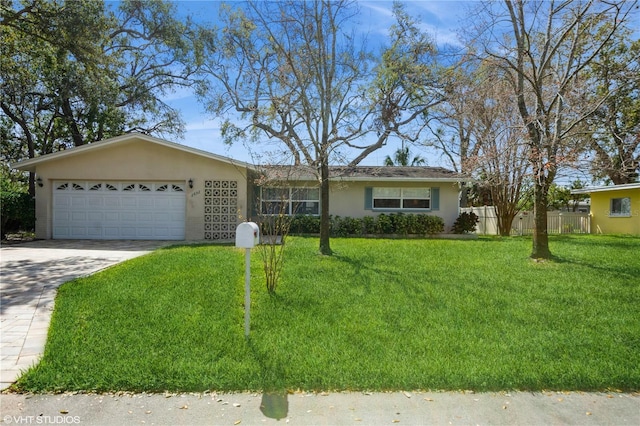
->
11;133;255;172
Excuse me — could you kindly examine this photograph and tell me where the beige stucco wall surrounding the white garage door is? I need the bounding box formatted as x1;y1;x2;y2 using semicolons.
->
36;140;247;240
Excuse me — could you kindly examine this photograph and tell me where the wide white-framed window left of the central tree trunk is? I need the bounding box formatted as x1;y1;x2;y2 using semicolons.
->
260;187;320;215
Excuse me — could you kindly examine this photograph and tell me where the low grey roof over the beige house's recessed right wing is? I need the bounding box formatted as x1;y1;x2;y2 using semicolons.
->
259;166;472;182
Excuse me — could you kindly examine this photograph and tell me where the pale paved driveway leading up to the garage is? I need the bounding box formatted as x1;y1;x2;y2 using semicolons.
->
0;240;176;389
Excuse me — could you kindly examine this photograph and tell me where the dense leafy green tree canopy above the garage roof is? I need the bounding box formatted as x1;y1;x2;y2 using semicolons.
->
0;0;199;176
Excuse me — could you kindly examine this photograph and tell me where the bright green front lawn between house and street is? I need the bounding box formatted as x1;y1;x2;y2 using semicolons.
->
16;236;640;391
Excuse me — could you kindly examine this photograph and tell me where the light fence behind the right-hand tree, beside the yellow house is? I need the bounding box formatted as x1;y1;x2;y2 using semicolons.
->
460;206;591;235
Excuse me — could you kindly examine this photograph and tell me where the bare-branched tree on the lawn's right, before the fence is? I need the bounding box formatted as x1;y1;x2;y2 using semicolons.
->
473;0;637;258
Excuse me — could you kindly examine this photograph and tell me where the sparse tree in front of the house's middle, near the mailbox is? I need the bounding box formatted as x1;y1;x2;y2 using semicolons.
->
200;0;439;254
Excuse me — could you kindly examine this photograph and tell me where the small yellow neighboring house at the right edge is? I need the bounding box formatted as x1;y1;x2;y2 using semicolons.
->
571;183;640;235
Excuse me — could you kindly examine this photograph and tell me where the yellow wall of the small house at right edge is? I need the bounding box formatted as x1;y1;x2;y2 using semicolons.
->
591;189;640;235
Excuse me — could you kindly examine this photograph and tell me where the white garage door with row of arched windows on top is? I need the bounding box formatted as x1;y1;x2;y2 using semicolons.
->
53;181;185;240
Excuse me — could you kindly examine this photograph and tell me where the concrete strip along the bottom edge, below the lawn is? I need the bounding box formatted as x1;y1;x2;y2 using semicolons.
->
0;392;640;425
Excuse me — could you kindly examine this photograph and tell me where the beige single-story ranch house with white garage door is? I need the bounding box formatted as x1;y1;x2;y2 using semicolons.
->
13;133;466;240
